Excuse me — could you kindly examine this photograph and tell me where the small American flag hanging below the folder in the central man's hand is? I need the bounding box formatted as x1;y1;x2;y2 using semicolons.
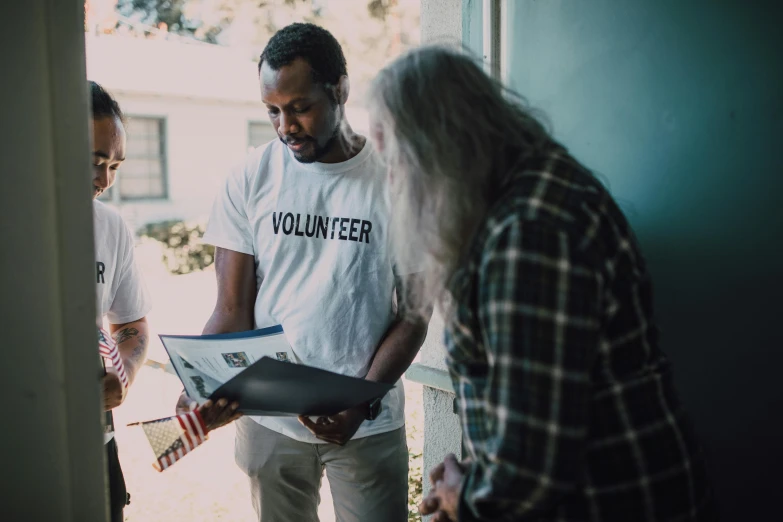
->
128;410;208;471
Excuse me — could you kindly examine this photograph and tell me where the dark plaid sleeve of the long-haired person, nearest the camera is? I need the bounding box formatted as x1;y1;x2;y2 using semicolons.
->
459;219;602;522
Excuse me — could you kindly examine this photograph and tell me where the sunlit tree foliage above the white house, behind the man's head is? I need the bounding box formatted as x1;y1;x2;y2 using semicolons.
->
112;0;419;100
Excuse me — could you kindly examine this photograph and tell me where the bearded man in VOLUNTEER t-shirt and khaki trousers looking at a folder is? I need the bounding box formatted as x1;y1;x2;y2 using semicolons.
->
178;24;427;522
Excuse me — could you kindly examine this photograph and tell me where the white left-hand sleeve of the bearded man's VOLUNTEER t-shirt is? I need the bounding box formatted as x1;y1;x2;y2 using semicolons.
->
203;160;255;255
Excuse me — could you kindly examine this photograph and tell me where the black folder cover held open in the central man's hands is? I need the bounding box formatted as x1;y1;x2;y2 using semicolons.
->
210;357;394;416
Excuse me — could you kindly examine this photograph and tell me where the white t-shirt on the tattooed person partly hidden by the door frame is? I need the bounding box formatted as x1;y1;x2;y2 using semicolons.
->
93;201;152;443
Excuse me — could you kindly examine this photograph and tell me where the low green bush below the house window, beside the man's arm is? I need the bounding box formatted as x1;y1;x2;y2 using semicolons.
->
139;221;215;275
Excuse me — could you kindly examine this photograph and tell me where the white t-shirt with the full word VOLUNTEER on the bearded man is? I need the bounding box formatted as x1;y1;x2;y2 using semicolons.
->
204;140;405;443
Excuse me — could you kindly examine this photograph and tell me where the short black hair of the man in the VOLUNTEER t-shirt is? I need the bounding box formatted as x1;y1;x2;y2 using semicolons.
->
258;23;348;86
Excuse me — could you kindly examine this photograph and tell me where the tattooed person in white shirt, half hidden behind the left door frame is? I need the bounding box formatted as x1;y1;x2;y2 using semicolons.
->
90;82;151;522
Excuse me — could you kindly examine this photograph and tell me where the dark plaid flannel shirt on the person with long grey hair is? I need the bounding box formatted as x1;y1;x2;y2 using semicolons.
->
446;148;713;522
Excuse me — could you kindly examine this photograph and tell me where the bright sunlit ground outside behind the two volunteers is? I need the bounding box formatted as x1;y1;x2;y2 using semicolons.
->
115;239;424;522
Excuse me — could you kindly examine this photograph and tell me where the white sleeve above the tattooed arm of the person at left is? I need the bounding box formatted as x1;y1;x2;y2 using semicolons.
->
106;221;152;324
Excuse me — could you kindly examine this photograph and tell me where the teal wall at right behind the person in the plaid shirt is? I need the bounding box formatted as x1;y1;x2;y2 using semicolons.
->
502;0;783;521
